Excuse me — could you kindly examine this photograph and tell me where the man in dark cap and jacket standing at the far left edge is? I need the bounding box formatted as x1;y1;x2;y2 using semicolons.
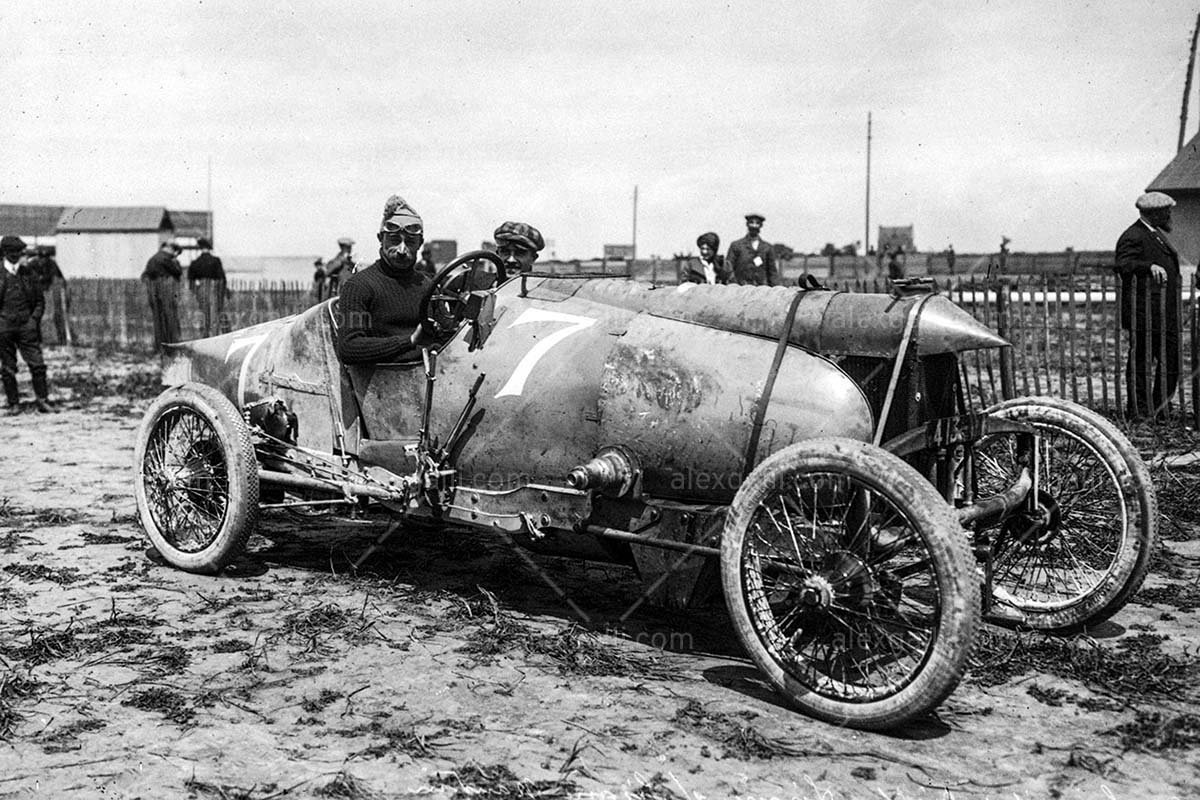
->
0;236;52;415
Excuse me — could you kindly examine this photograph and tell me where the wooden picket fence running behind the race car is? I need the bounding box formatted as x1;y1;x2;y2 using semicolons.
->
46;271;1200;427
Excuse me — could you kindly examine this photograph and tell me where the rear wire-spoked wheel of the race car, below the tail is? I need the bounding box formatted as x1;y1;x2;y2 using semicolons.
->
134;384;258;575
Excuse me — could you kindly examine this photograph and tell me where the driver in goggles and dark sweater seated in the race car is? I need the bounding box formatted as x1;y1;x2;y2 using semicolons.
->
337;194;433;363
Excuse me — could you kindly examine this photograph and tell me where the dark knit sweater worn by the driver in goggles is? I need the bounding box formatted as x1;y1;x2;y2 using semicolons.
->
337;260;430;363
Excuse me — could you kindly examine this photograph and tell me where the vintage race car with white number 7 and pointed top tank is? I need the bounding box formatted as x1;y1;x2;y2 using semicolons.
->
134;252;1158;728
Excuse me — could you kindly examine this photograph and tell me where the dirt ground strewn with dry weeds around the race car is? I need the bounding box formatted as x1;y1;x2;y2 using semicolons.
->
0;350;1200;800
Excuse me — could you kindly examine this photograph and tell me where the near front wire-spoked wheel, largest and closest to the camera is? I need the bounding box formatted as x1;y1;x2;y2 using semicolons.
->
721;438;980;729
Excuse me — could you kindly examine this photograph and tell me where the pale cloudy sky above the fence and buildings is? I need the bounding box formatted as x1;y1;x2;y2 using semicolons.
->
0;0;1200;259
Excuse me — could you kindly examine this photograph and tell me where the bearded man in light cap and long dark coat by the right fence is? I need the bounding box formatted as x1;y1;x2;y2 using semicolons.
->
1115;192;1182;419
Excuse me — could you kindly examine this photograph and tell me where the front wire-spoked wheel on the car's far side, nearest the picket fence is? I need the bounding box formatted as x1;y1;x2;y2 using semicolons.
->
976;397;1158;633
